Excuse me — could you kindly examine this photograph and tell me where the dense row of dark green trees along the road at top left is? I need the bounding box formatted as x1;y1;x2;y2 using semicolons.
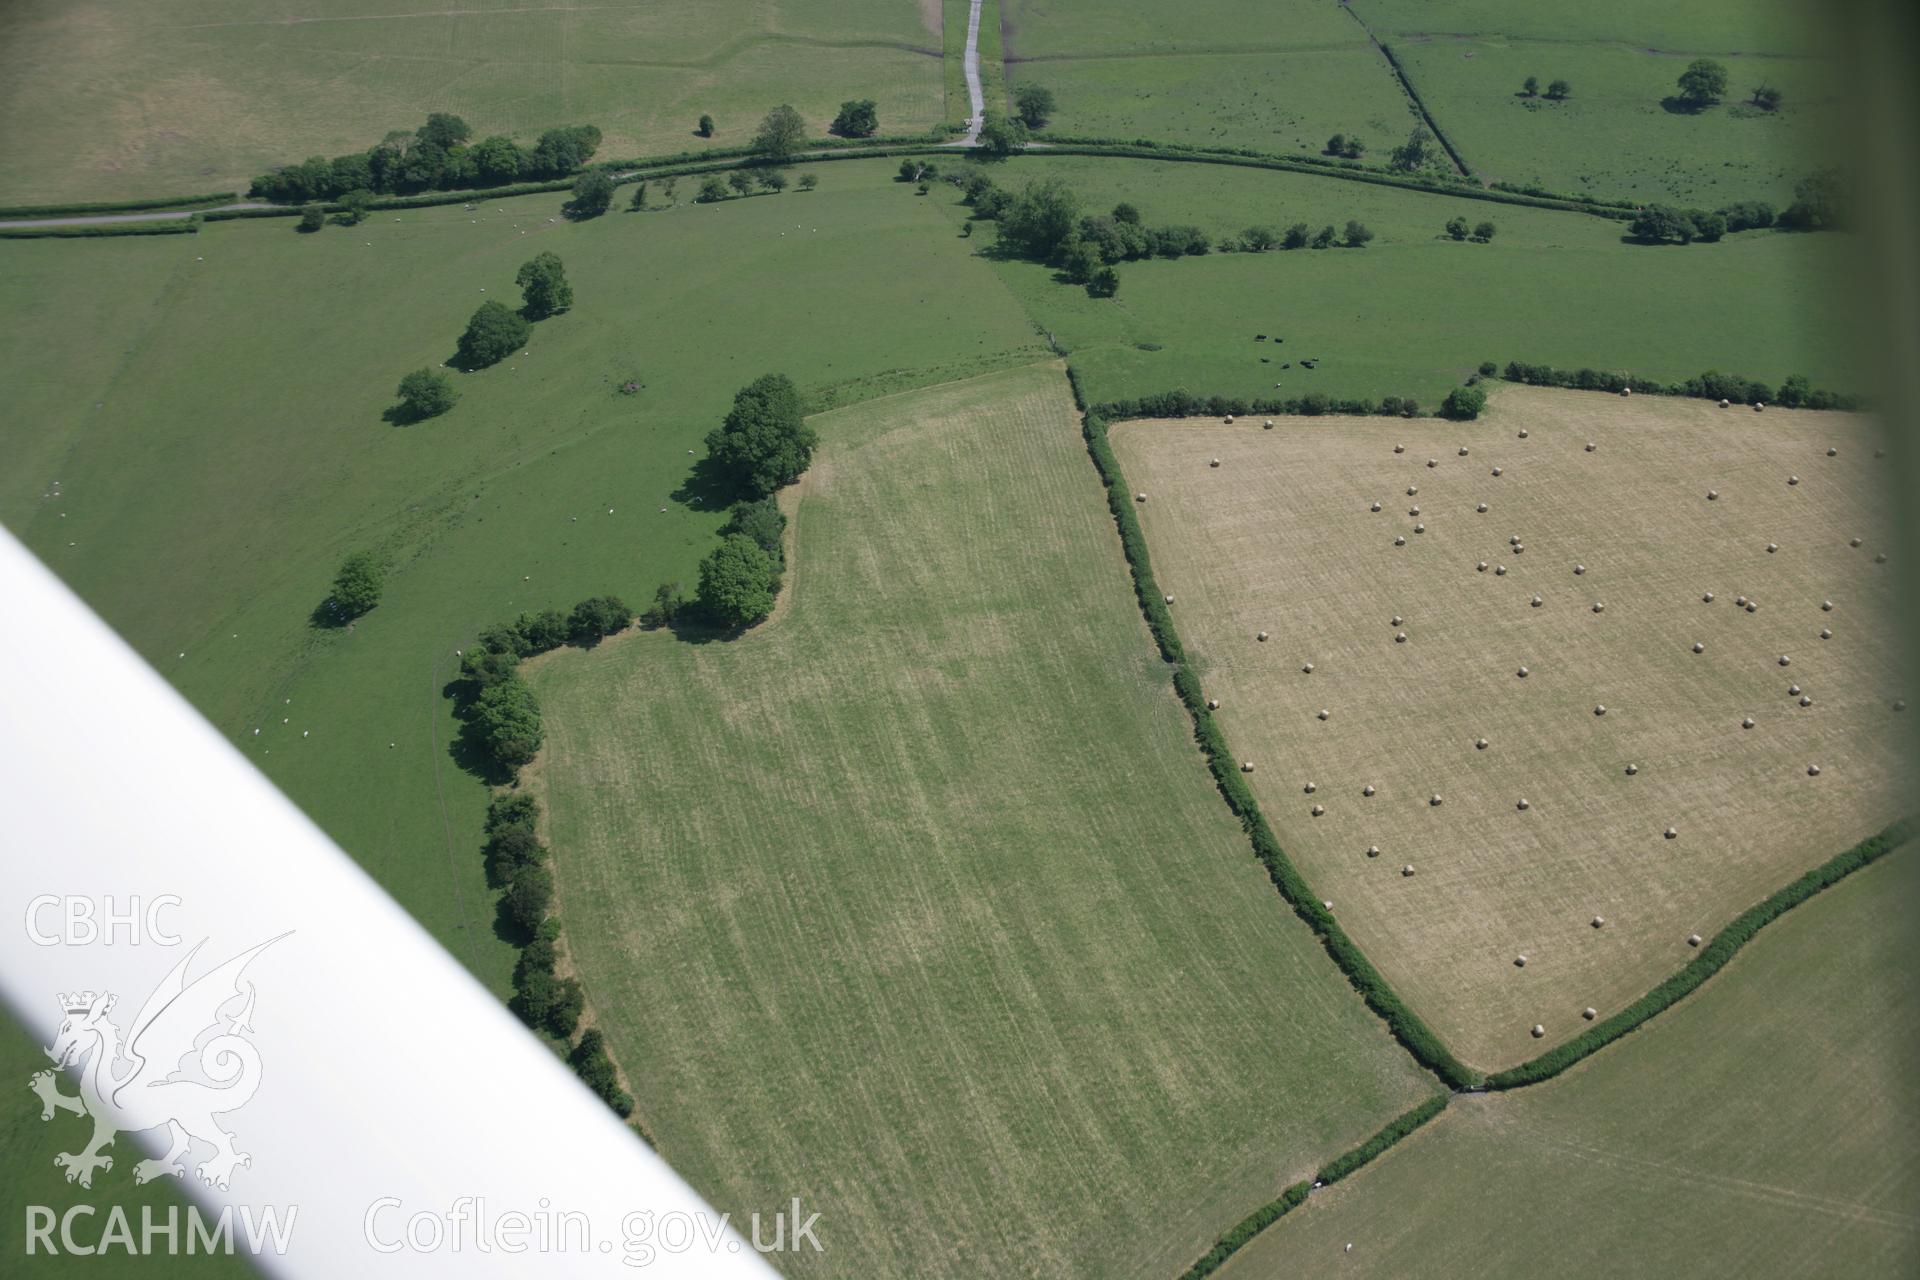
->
248;111;601;203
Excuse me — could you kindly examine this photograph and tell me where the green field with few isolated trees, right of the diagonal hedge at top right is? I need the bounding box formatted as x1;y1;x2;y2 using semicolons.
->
1394;36;1843;209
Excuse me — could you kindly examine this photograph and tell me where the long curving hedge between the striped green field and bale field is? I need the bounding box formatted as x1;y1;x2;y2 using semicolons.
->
1068;365;1480;1088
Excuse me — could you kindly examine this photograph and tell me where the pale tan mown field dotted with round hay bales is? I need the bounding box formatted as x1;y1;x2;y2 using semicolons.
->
1114;388;1908;1069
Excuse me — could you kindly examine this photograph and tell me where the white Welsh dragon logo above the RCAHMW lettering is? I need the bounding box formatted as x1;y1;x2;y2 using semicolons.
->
29;935;286;1190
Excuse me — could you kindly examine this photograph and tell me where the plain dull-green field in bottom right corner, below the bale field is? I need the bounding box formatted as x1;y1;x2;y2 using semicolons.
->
1219;848;1920;1280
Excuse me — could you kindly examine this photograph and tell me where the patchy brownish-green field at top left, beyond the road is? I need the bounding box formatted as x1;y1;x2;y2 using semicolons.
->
0;0;945;203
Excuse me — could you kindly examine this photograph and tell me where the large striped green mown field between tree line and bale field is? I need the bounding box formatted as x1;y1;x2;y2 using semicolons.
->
534;367;1427;1280
